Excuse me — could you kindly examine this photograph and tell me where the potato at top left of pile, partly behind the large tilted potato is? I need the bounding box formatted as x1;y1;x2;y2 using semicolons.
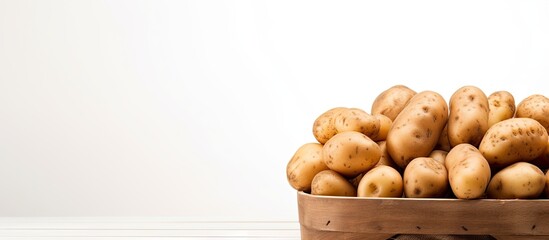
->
370;85;416;121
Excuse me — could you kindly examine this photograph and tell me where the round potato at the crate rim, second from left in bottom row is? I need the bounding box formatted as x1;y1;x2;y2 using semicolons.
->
357;166;402;197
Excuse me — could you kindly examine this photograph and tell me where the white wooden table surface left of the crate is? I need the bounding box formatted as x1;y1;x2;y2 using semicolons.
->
0;217;300;240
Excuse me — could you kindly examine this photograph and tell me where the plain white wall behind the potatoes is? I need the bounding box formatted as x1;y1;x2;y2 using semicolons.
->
0;0;549;221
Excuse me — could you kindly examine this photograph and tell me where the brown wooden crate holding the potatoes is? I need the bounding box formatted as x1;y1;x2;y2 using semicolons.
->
297;192;549;240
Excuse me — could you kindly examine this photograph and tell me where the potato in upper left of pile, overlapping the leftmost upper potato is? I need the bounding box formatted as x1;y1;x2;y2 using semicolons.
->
335;108;380;138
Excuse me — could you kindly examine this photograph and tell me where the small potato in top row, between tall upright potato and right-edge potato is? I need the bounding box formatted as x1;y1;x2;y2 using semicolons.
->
488;91;516;128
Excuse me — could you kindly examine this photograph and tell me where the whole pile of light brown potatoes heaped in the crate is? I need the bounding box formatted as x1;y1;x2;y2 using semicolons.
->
286;85;549;199
